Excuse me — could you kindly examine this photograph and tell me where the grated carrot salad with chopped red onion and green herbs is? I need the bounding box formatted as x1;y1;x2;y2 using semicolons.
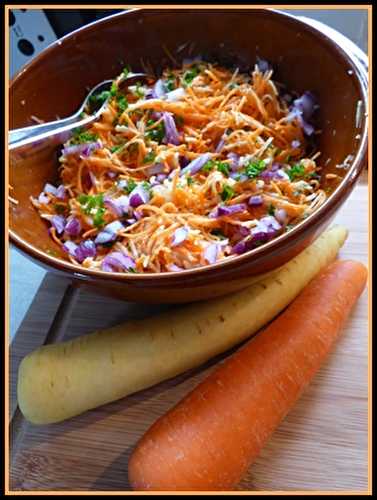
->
31;61;327;273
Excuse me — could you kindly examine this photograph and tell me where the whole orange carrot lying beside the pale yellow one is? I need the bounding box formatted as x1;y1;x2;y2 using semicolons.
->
128;261;367;491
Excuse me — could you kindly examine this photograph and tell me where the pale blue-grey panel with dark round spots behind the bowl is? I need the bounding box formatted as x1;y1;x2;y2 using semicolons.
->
9;9;57;78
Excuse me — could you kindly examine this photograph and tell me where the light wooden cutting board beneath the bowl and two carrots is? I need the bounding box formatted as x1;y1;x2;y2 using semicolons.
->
10;179;369;491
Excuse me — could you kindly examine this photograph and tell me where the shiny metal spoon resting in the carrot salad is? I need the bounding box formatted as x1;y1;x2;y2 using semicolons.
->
8;73;149;151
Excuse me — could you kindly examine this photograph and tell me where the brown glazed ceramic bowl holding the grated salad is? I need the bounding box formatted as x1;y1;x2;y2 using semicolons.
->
9;9;367;303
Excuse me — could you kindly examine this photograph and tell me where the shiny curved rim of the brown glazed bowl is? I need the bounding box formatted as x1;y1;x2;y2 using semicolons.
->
8;8;368;282
